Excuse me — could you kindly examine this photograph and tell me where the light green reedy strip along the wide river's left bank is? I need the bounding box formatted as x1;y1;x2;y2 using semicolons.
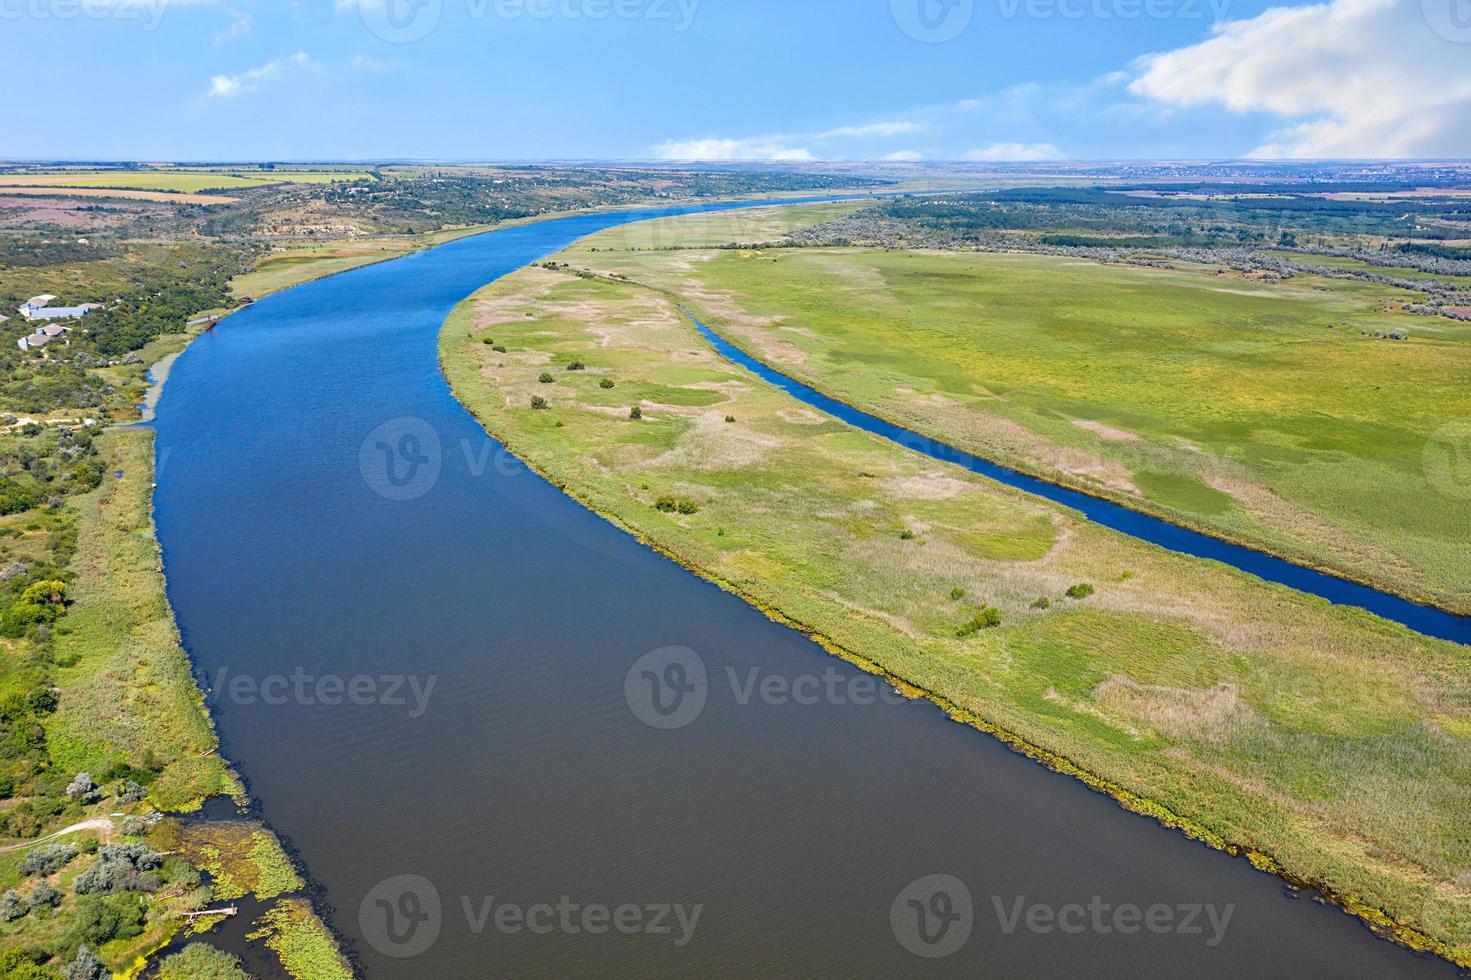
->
34;428;352;980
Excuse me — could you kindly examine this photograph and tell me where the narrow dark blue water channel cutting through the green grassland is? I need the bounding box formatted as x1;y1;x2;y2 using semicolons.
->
685;310;1471;643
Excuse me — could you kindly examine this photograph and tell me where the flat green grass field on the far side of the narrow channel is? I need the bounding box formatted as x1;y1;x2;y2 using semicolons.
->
572;209;1471;609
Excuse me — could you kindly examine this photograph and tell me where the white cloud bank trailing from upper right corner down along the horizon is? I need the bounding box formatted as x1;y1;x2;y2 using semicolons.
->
653;0;1471;162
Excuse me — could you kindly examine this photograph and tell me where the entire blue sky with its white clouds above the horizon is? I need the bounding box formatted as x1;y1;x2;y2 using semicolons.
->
0;0;1471;160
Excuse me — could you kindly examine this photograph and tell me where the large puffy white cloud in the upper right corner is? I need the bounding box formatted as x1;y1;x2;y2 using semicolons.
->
1130;0;1471;157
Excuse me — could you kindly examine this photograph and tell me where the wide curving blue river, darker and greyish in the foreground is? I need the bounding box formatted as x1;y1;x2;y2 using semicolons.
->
154;198;1455;979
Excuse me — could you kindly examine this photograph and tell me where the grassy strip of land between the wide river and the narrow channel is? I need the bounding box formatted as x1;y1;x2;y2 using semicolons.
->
441;206;1471;962
